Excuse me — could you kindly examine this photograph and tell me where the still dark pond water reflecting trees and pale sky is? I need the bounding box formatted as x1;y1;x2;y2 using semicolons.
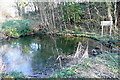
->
0;35;104;75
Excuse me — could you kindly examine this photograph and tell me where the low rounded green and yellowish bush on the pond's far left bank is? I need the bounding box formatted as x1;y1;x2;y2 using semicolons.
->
2;20;32;37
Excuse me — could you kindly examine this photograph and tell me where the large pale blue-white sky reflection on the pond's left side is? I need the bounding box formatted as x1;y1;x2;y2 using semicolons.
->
0;45;32;74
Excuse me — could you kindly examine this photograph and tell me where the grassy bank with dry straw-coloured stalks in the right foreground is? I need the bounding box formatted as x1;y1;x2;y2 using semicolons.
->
52;52;120;78
